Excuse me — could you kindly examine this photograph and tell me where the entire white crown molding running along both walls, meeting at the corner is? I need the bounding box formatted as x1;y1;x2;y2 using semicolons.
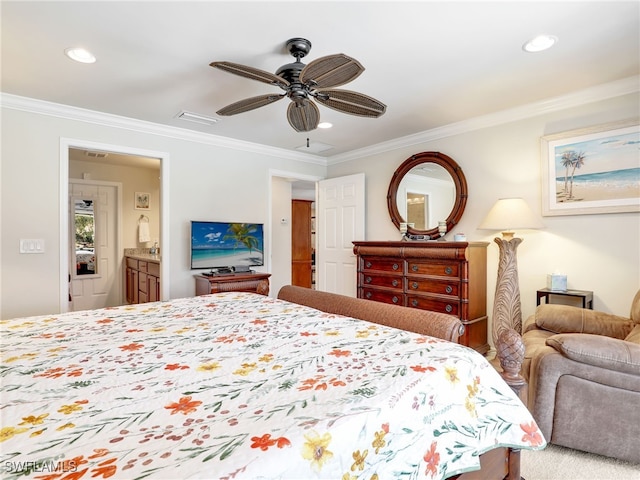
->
0;76;640;166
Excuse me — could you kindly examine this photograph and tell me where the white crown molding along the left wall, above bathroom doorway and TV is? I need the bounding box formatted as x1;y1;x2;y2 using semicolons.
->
0;92;327;166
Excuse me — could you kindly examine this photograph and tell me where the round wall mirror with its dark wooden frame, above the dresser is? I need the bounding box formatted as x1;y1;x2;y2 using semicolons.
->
387;152;468;240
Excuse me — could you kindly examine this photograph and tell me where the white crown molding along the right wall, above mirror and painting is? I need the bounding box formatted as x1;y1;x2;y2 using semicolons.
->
327;76;640;165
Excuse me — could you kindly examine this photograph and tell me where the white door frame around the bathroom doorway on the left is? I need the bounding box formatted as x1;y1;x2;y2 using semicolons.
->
59;137;171;313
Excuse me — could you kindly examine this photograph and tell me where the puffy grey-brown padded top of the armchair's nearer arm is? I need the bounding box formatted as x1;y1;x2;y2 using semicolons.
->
546;333;640;375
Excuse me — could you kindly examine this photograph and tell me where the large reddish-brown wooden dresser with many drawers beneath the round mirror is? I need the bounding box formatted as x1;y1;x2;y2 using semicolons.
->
353;241;489;354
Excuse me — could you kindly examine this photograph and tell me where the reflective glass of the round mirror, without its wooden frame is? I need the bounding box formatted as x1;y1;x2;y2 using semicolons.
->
396;163;456;230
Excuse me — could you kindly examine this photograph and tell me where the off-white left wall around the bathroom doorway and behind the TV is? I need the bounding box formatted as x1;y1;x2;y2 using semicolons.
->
0;102;326;318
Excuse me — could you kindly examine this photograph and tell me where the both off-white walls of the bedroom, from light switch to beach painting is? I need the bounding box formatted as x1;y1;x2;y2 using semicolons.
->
0;93;640;324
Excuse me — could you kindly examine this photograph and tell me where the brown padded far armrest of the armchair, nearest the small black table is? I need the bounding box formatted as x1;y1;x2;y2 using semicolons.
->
534;304;634;339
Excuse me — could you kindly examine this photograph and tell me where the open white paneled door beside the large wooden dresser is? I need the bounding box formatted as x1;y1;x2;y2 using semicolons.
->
316;173;365;297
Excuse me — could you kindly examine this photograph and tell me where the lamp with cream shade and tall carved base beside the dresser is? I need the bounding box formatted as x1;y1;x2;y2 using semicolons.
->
478;198;544;345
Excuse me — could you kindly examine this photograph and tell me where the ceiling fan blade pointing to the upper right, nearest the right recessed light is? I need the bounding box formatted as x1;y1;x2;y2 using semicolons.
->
300;53;364;88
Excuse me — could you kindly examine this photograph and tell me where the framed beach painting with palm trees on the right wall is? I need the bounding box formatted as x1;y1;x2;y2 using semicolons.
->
541;121;640;216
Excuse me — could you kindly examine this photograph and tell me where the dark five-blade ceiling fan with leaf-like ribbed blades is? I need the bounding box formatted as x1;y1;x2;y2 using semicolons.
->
210;38;387;132
